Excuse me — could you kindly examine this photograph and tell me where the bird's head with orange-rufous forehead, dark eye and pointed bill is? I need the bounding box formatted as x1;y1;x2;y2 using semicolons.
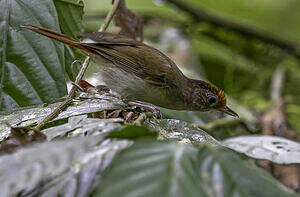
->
191;80;239;117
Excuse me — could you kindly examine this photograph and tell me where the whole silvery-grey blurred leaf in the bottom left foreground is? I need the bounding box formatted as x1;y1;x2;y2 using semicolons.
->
0;136;130;196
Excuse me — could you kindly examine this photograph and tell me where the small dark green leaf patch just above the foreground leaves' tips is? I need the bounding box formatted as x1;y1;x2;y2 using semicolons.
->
107;125;158;139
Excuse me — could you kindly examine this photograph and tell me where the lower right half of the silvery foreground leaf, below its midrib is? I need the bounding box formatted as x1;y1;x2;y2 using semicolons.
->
30;140;131;197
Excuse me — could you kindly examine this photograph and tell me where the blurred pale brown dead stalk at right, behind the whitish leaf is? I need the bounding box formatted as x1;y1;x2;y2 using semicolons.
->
258;66;300;190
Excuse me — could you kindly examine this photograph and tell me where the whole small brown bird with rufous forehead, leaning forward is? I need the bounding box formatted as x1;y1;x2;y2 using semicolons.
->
22;26;238;117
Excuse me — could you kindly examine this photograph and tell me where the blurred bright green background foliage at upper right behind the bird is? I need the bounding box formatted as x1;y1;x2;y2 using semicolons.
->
85;0;300;136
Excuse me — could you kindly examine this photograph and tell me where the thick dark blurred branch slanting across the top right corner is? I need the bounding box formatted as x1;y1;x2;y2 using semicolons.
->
166;0;300;58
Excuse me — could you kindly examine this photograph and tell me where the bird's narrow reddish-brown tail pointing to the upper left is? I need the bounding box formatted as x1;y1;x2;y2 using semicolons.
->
20;25;89;51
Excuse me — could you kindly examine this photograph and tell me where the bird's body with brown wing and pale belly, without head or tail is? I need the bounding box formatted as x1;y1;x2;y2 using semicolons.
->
85;33;186;109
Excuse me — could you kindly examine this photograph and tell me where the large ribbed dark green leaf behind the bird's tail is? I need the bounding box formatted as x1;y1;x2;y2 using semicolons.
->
0;0;66;110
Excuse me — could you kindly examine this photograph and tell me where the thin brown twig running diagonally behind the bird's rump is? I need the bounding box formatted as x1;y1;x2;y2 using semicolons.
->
34;0;119;129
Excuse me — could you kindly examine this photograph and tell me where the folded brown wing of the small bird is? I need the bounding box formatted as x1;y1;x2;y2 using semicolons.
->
82;33;185;87
